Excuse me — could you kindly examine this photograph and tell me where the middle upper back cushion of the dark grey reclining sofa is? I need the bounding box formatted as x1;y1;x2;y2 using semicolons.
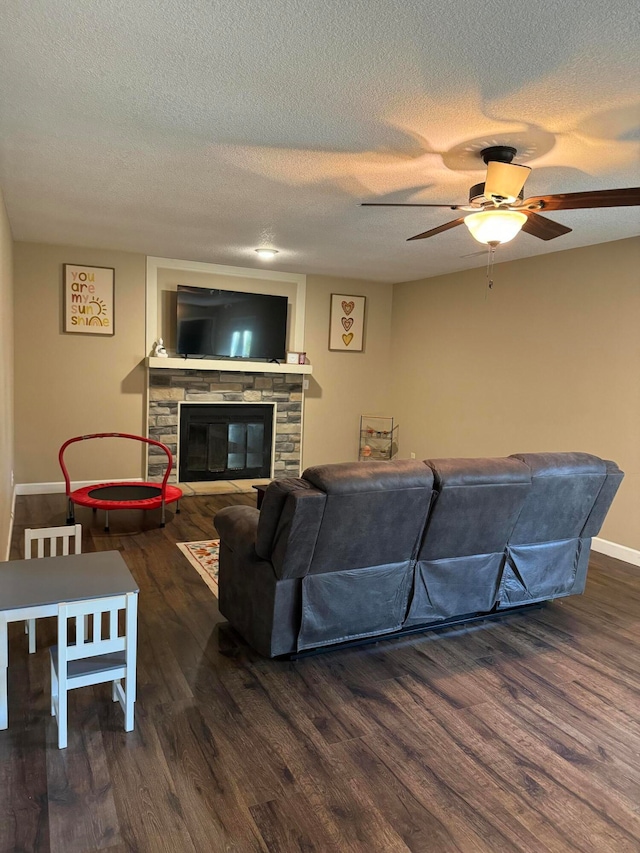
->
418;458;531;560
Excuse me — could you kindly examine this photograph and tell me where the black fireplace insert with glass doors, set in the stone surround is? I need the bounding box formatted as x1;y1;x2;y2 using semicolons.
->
178;403;275;483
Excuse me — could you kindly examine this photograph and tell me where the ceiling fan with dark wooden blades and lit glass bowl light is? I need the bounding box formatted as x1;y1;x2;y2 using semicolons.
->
362;145;640;248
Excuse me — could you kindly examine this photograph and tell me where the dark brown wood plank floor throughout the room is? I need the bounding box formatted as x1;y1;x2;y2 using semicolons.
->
0;495;640;853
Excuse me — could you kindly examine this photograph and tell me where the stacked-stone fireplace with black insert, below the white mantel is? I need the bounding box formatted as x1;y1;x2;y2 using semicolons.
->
147;368;303;483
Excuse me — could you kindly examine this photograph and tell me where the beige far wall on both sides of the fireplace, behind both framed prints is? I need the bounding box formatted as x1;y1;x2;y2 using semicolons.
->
15;250;392;483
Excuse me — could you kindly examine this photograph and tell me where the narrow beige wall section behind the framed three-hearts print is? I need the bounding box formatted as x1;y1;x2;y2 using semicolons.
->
303;275;393;467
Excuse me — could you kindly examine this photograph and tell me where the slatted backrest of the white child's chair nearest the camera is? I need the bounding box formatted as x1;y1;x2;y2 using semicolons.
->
58;592;136;669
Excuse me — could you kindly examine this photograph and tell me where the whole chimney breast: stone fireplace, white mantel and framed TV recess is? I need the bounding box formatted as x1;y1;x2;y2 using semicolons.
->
146;257;312;487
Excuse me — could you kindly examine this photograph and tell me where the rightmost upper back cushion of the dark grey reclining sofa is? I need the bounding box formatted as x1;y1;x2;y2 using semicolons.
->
509;453;607;545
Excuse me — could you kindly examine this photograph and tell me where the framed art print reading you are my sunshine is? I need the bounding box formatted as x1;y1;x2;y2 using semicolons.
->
63;264;115;335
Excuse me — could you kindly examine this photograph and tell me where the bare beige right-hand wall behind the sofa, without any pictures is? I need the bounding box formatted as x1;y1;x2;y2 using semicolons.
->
391;238;640;549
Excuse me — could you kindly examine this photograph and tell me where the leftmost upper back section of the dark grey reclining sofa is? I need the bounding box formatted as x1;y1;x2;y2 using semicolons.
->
256;459;433;579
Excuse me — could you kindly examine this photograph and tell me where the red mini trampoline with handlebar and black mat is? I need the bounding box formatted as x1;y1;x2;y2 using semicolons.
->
58;432;182;530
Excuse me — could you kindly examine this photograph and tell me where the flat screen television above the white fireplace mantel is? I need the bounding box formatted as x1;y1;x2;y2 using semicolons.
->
176;285;287;361
